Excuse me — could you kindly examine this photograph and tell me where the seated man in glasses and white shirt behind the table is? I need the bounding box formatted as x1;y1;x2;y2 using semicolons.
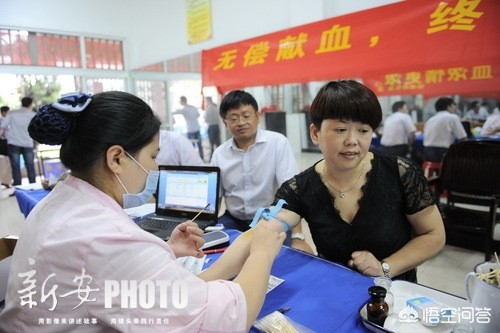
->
211;90;312;252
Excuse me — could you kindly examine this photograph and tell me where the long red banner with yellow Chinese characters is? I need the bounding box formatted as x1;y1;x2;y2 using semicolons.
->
202;0;500;97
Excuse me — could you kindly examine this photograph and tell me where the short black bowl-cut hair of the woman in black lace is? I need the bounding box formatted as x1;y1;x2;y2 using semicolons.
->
310;80;382;130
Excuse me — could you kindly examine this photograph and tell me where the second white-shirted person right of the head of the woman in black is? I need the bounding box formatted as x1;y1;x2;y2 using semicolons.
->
424;97;467;163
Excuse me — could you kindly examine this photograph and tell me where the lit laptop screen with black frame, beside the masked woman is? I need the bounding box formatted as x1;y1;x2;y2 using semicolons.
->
156;166;220;220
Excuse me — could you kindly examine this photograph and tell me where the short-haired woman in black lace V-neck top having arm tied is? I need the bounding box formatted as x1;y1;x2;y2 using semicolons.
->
257;80;445;282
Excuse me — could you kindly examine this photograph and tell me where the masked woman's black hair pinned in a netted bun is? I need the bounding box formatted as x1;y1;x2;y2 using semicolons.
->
29;91;161;177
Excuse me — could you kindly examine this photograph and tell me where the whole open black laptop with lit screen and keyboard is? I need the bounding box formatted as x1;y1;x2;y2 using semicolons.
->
137;165;220;240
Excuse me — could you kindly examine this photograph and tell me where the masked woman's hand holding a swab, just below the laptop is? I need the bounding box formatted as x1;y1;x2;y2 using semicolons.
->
167;221;205;258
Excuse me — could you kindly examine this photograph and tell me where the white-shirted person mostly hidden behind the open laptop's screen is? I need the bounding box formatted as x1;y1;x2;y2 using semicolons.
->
156;130;205;165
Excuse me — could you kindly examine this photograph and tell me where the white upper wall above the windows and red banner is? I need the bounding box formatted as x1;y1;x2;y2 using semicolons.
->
0;0;397;69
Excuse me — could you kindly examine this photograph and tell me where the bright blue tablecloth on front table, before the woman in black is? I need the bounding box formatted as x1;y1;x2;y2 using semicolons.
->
205;230;373;332
